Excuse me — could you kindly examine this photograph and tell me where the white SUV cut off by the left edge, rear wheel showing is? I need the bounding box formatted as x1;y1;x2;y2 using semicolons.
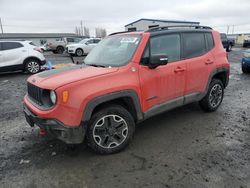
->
0;40;46;74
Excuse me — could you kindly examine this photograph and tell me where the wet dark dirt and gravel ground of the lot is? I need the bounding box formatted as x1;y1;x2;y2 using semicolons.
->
0;48;250;188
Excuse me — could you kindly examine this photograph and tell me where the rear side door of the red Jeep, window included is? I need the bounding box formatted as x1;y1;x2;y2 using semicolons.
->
182;32;215;97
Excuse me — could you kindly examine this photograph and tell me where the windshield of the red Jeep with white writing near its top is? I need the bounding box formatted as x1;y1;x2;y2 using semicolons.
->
84;35;141;67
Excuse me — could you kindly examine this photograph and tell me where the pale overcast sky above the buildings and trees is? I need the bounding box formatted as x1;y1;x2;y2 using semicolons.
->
0;0;250;34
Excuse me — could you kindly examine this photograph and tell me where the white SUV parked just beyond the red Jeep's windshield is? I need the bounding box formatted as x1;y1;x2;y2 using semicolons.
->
66;38;101;56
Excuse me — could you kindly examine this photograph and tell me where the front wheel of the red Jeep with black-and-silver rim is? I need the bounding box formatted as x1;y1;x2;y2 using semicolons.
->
86;105;135;154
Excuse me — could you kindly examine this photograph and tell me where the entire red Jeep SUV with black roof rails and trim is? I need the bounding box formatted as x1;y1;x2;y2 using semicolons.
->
24;26;229;154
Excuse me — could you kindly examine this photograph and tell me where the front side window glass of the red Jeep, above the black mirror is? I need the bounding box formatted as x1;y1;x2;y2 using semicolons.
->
150;34;181;62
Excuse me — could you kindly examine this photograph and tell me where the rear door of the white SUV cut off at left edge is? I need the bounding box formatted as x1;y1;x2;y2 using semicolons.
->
0;42;27;67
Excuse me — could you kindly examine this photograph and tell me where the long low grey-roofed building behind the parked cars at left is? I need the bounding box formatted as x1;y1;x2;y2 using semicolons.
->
0;33;86;46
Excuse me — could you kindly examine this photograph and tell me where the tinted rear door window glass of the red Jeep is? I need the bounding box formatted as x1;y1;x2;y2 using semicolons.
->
183;33;206;58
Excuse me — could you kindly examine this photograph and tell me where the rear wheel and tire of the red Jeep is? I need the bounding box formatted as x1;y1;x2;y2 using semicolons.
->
199;79;224;112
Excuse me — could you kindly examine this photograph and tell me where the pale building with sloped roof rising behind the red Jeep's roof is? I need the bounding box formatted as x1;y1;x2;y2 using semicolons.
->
125;18;200;31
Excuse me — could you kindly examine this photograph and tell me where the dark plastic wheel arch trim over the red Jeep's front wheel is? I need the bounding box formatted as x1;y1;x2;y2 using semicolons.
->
82;90;143;122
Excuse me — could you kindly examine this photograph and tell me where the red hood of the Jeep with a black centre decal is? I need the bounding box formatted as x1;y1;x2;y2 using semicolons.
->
27;65;119;90
